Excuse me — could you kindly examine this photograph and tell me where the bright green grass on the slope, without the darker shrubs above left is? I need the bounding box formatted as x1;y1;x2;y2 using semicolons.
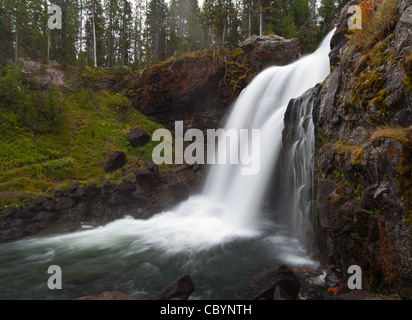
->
0;65;166;210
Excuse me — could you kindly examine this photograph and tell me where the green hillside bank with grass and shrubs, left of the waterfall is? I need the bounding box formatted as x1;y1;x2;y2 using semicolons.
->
0;66;161;210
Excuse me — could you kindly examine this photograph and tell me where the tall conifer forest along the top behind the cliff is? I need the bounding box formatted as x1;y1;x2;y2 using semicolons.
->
0;0;347;68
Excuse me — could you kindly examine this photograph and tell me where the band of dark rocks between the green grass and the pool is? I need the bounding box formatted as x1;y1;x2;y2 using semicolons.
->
0;162;202;241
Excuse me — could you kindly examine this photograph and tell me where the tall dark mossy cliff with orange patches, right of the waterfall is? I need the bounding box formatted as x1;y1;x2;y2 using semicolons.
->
314;0;412;297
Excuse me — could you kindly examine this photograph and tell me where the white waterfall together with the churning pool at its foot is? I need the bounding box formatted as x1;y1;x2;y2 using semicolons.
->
0;32;333;299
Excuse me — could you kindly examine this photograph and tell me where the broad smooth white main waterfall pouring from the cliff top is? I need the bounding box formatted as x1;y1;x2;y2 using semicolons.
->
204;32;333;228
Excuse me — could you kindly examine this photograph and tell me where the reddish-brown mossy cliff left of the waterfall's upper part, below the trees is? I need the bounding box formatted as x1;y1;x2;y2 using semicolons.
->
131;36;300;130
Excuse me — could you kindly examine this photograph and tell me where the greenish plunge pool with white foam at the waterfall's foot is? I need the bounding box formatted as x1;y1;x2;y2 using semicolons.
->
0;197;324;300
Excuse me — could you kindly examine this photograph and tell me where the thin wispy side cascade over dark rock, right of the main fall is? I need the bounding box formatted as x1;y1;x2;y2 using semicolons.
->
274;87;319;247
